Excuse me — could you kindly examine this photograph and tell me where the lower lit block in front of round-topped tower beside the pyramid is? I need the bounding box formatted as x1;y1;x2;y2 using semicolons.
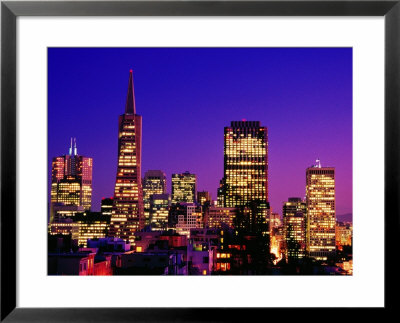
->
150;194;171;231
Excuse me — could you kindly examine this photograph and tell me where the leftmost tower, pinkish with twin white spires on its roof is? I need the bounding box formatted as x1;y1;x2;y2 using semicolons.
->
50;138;93;217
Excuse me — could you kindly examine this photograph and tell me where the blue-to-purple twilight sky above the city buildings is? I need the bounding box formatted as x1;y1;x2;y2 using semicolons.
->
48;48;352;220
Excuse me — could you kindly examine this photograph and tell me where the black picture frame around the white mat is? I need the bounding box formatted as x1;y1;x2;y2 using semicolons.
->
0;0;400;322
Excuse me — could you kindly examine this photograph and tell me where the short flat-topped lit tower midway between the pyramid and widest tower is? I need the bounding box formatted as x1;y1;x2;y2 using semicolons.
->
172;171;197;204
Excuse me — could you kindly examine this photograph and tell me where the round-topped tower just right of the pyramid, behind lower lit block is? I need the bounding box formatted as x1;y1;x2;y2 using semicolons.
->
143;170;167;225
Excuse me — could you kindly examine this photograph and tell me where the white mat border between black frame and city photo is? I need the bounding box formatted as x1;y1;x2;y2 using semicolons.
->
17;17;384;307
